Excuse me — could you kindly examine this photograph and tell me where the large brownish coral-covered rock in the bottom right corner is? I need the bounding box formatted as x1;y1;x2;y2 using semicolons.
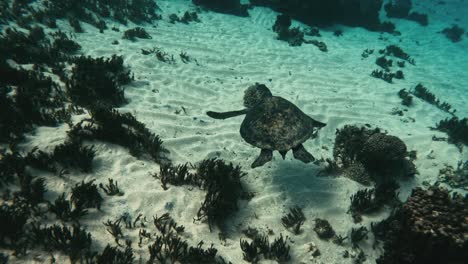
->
372;187;468;264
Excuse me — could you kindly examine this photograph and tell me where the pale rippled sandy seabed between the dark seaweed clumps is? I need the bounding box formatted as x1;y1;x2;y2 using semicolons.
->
6;0;468;263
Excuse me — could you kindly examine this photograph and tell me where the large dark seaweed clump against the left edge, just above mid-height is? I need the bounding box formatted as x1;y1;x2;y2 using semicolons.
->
0;61;70;143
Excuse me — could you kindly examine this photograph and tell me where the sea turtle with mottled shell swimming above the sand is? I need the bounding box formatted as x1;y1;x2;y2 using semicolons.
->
207;83;326;168
